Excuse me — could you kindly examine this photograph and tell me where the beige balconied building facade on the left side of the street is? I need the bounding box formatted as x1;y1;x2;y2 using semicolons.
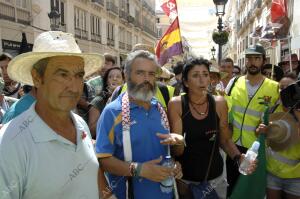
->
0;0;157;64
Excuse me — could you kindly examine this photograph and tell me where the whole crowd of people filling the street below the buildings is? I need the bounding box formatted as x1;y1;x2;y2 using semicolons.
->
0;31;300;199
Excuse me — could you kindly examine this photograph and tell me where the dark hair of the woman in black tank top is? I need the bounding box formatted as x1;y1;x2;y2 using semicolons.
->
182;58;209;94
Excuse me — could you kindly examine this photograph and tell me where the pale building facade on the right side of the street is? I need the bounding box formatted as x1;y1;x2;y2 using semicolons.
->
230;0;300;68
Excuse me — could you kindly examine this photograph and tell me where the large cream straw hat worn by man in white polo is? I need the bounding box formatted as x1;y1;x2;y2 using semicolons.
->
7;31;104;85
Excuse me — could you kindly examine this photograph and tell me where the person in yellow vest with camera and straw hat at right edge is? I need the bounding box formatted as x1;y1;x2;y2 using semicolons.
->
257;83;300;199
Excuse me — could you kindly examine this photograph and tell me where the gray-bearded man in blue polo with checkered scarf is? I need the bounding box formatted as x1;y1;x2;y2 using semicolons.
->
96;50;184;199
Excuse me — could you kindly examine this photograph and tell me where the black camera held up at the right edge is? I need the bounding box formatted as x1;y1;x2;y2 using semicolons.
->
280;80;300;109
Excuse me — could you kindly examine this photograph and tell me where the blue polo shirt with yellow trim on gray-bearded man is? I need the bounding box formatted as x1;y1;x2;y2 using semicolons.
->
96;94;173;199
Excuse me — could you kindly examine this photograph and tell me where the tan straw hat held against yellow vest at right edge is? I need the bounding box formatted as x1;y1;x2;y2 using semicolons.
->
266;112;300;151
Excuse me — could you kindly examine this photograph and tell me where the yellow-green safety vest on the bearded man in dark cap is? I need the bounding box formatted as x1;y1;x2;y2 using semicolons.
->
227;76;279;148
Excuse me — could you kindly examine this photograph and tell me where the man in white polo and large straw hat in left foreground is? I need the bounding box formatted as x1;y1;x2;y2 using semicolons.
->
0;31;103;199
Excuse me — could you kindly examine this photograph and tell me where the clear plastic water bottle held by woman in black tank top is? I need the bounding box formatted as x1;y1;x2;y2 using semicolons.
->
239;141;260;175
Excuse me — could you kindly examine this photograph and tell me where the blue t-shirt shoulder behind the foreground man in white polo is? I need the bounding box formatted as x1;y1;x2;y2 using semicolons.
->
2;93;35;124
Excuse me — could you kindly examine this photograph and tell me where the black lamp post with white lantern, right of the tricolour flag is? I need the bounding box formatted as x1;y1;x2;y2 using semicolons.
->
213;0;227;64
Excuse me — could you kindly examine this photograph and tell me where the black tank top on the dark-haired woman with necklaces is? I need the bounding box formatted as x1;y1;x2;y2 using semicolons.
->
178;94;223;182
